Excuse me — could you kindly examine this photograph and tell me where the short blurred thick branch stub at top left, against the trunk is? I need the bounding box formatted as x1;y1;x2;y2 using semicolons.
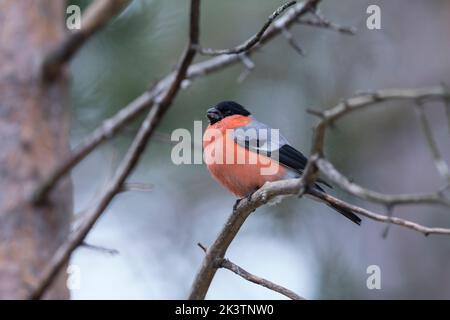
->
42;0;131;81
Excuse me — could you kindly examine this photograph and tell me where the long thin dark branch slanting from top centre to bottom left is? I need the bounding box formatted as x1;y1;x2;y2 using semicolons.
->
28;0;200;299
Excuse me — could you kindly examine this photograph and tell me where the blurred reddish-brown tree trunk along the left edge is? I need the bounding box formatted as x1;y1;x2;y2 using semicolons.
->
0;0;72;299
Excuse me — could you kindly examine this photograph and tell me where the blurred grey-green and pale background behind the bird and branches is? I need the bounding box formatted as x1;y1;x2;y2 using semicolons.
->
70;0;450;299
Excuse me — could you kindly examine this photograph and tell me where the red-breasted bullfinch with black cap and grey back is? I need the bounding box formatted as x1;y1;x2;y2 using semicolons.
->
203;101;361;225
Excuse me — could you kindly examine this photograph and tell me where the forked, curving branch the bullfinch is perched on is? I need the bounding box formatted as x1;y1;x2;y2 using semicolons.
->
189;87;450;300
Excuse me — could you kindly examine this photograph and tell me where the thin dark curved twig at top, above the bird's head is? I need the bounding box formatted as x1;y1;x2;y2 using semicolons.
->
198;1;297;56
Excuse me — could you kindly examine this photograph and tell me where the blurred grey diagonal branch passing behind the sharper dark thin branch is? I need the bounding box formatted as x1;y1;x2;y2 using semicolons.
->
31;0;320;205
